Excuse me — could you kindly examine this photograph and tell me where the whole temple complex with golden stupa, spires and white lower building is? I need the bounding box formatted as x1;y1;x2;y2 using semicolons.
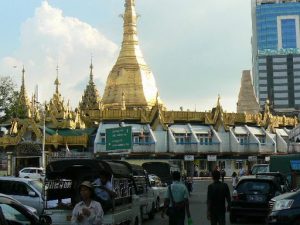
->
0;0;298;174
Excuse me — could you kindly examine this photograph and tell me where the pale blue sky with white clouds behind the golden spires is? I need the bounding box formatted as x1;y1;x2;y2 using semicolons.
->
0;0;251;111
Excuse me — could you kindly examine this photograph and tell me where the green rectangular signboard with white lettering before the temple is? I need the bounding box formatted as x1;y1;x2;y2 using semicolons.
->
106;126;132;151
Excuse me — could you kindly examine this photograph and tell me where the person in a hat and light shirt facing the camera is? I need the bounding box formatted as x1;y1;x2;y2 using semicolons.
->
71;181;103;225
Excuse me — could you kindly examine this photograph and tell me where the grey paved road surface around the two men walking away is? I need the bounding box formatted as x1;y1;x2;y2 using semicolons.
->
143;180;264;225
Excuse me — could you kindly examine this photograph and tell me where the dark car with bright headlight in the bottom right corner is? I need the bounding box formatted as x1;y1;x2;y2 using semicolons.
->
267;190;300;225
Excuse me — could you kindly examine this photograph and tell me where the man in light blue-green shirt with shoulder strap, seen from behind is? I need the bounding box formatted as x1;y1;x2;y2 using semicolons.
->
161;171;192;225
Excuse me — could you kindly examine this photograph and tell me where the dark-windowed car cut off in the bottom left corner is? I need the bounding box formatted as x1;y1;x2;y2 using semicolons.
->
0;194;51;225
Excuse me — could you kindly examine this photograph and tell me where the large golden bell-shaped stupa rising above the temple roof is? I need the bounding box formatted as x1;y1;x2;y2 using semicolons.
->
102;0;162;109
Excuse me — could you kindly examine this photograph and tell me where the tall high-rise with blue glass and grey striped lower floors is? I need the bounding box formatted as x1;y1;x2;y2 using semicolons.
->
252;0;300;112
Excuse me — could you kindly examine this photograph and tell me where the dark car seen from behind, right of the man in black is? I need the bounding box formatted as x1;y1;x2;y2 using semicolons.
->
230;175;282;223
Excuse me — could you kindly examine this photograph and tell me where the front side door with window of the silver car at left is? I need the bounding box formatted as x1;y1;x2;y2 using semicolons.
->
11;181;40;213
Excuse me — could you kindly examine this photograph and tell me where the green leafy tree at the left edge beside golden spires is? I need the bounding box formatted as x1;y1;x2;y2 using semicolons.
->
0;76;19;122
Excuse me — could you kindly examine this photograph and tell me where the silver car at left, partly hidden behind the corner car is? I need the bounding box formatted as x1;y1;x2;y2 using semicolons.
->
0;177;44;215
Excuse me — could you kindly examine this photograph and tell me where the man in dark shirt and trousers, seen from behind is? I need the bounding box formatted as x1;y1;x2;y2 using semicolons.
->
207;170;231;225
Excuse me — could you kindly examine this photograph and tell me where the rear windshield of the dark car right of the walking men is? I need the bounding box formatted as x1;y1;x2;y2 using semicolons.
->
236;180;271;194
